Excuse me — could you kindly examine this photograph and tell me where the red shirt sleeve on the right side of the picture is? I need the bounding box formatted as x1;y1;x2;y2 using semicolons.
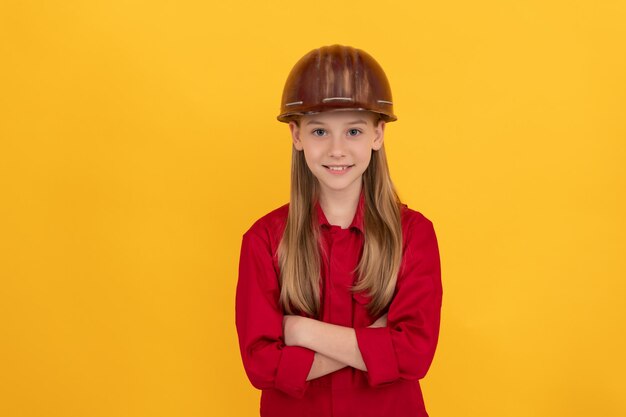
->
355;216;443;387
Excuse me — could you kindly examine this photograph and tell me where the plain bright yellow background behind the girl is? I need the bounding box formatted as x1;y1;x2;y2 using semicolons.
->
0;0;626;417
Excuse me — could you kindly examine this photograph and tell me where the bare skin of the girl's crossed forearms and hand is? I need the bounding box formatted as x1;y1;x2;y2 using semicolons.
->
283;314;387;381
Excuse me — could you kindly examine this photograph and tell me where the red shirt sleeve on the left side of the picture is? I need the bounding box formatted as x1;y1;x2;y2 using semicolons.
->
235;230;315;398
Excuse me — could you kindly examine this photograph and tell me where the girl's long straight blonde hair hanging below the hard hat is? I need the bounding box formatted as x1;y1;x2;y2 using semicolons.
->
278;115;402;319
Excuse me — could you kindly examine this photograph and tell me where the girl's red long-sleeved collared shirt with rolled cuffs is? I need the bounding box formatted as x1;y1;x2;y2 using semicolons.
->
235;192;443;417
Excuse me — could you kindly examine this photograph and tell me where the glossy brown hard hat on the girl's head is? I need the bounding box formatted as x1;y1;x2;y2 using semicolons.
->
277;45;398;123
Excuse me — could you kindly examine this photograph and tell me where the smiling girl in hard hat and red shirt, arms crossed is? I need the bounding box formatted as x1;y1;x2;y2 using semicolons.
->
235;45;443;417
